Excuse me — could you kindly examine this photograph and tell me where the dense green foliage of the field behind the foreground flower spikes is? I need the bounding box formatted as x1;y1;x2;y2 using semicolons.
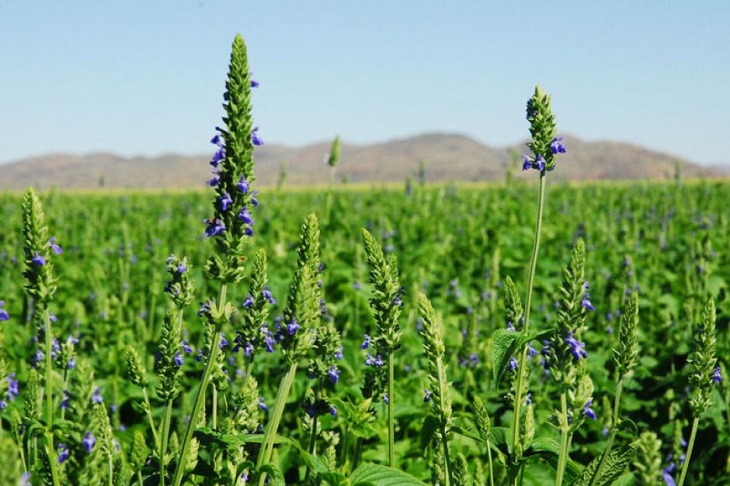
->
0;179;730;484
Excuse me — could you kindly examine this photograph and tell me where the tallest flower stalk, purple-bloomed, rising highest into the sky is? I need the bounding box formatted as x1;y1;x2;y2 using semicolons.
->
173;35;263;486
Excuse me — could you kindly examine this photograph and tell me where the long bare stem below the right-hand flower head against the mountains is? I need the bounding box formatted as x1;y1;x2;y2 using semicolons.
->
512;171;546;479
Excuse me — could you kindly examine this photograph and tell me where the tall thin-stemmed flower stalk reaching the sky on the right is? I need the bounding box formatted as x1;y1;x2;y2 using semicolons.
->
510;86;566;484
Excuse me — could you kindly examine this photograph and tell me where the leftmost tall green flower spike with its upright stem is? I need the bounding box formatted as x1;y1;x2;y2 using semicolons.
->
22;189;62;485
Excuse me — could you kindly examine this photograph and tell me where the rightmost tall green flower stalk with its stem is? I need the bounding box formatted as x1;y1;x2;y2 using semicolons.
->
677;297;722;486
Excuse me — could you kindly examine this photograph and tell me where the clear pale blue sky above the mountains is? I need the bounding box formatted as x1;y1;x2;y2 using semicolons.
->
0;0;730;164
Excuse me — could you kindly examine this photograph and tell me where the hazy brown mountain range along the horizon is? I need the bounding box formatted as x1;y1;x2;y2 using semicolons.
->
0;133;730;190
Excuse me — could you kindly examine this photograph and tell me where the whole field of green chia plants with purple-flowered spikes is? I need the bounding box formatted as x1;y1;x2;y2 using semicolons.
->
0;37;730;486
